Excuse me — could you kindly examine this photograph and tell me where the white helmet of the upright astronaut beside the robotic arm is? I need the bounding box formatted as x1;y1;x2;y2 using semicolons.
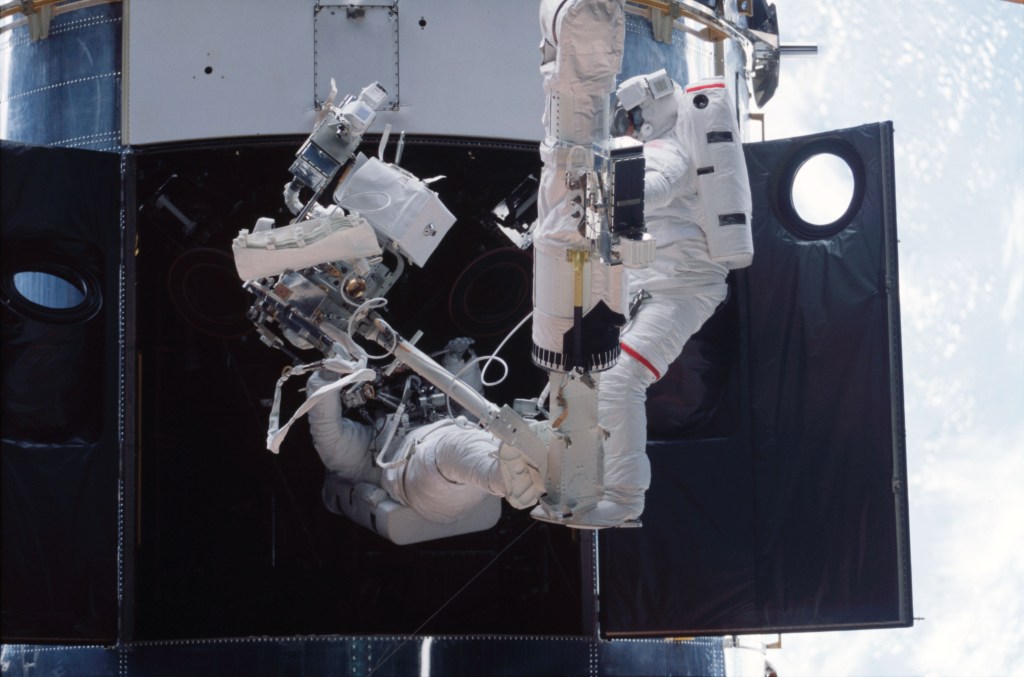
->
612;69;679;141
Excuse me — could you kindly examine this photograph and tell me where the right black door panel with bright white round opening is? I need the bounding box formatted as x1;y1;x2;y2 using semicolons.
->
600;123;912;636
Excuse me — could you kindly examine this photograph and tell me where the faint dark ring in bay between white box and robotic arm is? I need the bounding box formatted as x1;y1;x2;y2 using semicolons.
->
449;247;532;337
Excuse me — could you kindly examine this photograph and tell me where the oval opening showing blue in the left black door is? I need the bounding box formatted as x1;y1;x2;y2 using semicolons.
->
2;260;102;324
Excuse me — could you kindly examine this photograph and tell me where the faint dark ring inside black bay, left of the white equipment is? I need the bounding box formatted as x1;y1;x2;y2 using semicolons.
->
167;248;253;338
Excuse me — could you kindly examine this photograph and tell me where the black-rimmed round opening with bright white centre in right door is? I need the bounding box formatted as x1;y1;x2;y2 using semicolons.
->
771;139;864;240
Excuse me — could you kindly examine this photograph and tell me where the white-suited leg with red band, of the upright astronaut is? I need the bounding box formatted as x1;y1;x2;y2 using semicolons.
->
587;236;727;525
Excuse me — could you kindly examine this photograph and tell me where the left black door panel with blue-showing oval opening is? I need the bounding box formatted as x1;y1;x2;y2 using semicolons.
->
0;142;122;642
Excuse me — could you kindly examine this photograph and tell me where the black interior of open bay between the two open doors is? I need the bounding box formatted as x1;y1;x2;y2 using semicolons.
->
131;138;584;640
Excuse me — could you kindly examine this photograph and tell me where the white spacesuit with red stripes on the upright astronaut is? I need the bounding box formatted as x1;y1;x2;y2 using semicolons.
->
588;70;753;526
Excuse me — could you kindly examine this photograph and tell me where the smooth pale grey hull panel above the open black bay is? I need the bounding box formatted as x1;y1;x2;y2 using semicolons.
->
124;0;544;145
